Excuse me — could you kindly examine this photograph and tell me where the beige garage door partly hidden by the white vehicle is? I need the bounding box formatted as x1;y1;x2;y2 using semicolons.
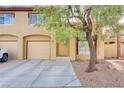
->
0;41;17;59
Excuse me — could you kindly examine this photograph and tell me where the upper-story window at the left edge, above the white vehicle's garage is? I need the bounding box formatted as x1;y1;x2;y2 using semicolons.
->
0;13;14;24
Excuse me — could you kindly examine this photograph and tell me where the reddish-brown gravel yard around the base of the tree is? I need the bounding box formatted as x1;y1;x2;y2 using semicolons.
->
72;60;124;87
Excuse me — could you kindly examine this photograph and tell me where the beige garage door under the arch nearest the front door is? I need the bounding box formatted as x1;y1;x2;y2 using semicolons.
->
27;41;50;59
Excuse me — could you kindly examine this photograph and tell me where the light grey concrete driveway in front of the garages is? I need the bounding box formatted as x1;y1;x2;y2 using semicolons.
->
0;60;81;88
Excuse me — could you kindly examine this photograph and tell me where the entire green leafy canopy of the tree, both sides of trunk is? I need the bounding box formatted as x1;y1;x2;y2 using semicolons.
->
34;5;124;43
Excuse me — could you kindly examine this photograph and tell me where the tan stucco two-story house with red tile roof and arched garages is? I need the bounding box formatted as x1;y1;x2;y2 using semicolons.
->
0;6;104;60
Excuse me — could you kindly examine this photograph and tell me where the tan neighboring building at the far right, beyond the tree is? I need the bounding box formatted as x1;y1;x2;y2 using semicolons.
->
104;30;124;58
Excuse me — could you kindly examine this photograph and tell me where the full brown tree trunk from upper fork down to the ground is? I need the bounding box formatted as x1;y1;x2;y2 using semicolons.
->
83;7;97;72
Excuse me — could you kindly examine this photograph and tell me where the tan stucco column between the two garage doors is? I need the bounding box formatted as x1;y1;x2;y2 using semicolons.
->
17;37;23;59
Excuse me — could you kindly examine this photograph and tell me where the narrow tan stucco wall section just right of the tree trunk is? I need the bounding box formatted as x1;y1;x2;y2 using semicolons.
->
97;40;104;61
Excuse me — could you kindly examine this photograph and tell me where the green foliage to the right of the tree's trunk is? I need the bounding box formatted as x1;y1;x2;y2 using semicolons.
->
92;5;124;40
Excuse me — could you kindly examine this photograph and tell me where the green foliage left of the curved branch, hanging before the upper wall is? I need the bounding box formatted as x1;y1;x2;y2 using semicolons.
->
34;6;77;44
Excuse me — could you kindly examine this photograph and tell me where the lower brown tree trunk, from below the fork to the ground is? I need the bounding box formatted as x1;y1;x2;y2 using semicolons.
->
87;32;97;72
